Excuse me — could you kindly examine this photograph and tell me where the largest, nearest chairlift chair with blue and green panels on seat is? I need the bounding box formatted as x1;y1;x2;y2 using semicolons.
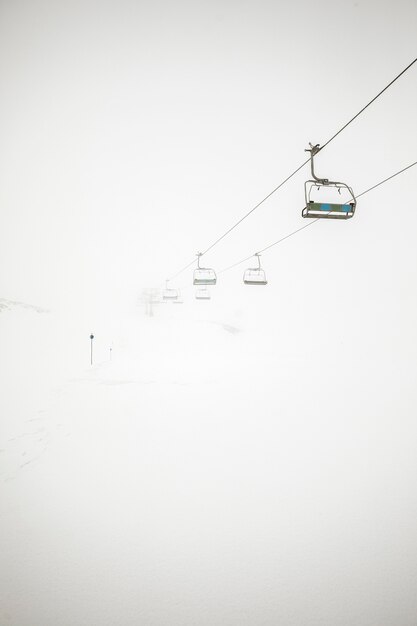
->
302;144;356;220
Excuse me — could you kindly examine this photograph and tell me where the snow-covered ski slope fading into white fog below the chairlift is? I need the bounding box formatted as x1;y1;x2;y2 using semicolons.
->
0;304;417;626
